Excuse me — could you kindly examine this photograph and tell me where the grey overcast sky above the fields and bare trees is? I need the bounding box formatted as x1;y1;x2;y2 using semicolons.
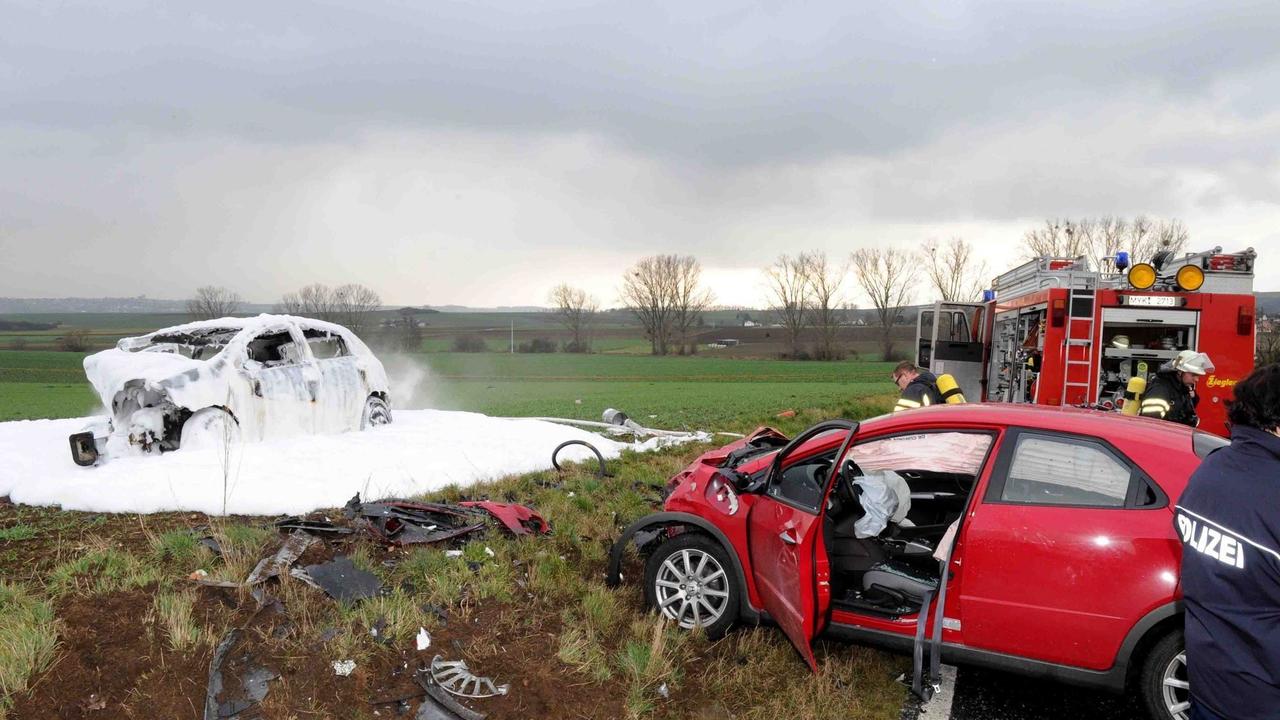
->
0;0;1280;306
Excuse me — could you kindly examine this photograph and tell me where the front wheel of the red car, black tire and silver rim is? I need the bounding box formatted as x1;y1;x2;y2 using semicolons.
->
644;532;742;638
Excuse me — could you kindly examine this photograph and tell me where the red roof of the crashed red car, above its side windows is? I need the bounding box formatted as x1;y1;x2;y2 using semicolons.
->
863;402;1194;448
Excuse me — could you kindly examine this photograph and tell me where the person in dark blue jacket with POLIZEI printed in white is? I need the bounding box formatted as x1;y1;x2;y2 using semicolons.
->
1174;364;1280;720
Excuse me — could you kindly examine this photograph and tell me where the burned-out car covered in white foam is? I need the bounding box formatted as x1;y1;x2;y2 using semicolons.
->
70;315;392;465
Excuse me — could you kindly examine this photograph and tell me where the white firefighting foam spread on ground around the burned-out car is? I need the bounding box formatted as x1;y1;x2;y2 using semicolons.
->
0;410;680;515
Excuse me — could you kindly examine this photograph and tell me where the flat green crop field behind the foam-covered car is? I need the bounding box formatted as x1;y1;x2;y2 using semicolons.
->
0;350;895;429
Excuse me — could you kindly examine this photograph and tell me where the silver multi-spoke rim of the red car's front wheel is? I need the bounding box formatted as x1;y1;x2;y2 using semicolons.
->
654;550;731;630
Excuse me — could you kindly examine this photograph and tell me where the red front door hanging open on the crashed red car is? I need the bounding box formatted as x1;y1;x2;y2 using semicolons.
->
748;420;858;671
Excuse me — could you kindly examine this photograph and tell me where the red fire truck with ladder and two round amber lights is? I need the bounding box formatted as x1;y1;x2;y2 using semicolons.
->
916;247;1257;436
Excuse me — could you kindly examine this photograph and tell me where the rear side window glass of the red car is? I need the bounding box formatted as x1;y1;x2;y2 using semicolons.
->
1000;434;1133;507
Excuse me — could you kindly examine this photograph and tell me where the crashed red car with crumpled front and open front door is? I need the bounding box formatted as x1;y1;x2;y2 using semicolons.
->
609;405;1226;720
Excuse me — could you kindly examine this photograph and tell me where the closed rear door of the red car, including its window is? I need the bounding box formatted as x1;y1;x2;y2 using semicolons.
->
959;429;1179;670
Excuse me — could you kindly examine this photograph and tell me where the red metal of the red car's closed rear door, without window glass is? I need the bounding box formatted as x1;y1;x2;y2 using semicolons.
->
957;432;1178;670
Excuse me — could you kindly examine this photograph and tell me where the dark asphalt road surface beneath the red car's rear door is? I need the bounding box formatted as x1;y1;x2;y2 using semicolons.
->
951;667;1146;720
